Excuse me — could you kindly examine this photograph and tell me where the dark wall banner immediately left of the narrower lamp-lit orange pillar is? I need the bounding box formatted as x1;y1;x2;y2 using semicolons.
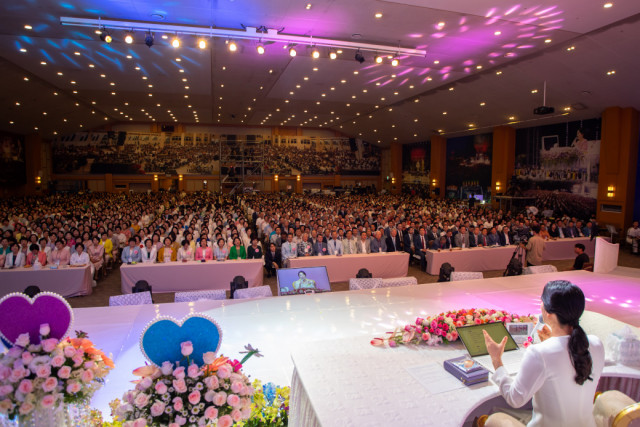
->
445;133;493;200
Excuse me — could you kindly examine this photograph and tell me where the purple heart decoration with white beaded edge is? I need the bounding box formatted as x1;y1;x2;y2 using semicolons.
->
0;292;73;344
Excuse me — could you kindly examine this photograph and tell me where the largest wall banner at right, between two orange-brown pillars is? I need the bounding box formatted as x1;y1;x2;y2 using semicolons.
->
507;118;601;218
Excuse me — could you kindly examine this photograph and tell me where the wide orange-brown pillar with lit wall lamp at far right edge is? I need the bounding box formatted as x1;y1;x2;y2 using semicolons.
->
596;107;639;229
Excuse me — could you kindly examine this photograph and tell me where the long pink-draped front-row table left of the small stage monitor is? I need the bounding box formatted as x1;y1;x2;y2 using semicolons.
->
120;259;264;294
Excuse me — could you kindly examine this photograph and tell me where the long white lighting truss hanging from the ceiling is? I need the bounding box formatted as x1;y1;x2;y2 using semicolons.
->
60;16;427;57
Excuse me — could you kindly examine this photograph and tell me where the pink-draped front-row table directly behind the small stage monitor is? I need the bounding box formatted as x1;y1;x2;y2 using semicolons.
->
289;252;409;283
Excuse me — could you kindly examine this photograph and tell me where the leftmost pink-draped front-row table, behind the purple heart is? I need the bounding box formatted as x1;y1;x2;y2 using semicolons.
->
0;266;93;297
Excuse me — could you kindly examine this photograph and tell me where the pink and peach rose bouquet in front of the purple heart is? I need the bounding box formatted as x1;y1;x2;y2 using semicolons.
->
0;323;113;419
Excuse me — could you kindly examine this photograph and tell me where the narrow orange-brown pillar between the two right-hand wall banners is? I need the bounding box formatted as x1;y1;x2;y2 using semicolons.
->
491;126;516;204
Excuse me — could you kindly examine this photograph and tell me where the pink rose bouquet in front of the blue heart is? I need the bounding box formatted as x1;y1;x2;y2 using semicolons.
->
111;341;261;427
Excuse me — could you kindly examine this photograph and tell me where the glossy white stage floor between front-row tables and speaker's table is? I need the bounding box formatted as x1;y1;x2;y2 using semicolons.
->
67;269;640;422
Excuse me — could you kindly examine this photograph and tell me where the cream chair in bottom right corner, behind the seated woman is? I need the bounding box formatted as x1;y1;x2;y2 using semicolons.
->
593;390;640;427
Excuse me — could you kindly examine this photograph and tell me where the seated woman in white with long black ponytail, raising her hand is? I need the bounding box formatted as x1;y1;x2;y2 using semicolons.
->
484;280;604;427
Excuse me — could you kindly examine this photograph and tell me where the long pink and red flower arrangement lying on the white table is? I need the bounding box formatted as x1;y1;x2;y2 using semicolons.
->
371;308;538;347
